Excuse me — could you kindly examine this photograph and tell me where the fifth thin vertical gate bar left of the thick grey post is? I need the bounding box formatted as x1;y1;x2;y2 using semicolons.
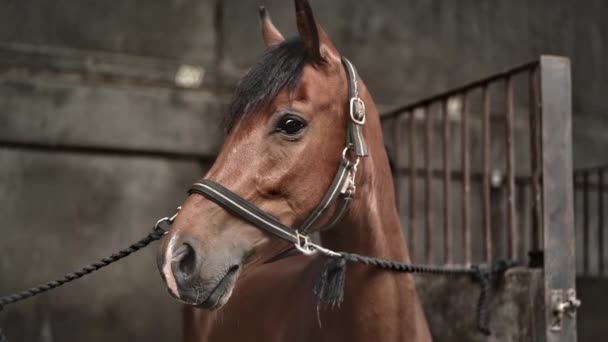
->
441;99;452;264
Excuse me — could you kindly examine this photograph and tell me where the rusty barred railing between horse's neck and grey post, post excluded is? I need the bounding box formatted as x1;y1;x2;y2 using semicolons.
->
382;61;541;264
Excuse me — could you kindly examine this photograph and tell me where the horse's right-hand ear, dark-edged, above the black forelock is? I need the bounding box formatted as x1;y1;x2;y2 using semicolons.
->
295;0;340;62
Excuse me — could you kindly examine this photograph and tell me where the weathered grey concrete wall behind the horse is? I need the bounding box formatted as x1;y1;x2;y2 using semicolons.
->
0;0;608;341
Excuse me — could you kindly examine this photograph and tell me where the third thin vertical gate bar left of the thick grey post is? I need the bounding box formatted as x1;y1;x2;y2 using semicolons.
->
481;84;492;263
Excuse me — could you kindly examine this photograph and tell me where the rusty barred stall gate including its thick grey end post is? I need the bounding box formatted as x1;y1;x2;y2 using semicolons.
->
382;56;579;342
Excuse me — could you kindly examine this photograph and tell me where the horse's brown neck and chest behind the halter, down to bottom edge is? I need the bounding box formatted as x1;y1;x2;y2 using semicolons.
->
321;91;431;342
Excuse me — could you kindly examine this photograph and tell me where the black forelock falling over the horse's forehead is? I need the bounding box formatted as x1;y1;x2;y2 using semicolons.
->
224;38;307;131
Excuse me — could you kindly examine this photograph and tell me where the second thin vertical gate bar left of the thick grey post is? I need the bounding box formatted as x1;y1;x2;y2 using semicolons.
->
505;76;519;260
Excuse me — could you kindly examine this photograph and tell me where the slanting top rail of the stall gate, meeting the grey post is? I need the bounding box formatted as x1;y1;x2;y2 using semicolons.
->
381;61;538;120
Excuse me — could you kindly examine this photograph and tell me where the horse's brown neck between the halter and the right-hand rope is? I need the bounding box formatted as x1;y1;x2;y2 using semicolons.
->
321;88;409;262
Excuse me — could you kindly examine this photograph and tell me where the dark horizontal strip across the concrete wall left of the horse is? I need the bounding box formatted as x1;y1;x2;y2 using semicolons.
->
0;140;214;162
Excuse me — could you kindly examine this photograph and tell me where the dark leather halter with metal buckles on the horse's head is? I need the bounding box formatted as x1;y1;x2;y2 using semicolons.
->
188;57;368;260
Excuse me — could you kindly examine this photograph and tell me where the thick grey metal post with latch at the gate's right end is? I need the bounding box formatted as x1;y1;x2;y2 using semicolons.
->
540;56;576;342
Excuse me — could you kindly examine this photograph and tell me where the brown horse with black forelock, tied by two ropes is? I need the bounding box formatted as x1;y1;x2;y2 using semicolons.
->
158;0;431;342
